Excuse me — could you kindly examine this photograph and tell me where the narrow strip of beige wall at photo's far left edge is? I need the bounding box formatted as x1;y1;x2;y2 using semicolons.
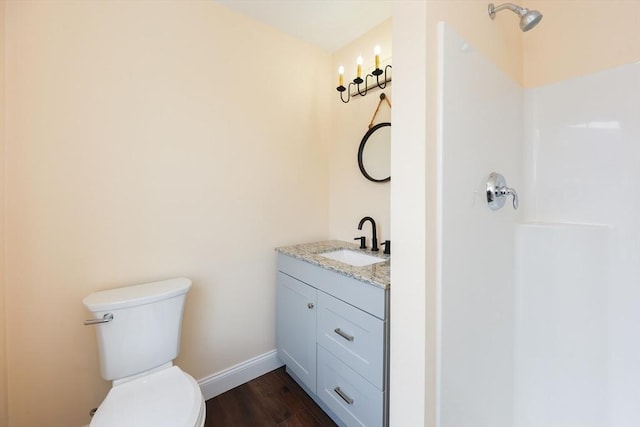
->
0;0;7;427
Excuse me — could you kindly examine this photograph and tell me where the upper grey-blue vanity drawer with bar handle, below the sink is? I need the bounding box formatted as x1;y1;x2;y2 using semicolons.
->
317;292;385;390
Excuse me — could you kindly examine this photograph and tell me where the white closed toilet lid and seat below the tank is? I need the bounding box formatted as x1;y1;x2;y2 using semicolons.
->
90;366;205;427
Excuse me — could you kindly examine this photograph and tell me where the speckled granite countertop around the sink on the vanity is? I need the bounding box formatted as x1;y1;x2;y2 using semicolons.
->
276;240;391;289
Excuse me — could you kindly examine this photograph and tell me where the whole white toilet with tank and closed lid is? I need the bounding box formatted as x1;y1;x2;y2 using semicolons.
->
82;278;205;427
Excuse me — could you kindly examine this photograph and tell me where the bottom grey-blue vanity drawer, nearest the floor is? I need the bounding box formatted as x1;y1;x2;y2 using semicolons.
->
317;345;385;427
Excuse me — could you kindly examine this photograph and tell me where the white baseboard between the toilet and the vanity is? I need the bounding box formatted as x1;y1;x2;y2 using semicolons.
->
198;350;283;400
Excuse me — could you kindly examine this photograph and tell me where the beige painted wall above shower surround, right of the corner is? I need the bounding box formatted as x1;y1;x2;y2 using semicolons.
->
523;0;640;87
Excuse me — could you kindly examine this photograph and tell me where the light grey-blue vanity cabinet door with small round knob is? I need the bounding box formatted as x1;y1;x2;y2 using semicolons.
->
276;272;317;393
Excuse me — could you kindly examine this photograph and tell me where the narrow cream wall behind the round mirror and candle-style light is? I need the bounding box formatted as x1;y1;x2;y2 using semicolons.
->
329;19;393;247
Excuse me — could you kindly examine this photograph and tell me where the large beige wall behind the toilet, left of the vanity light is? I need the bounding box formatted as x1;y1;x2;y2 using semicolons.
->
2;1;334;427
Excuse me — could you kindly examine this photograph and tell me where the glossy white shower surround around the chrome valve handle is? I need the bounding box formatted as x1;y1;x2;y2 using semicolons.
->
438;24;640;427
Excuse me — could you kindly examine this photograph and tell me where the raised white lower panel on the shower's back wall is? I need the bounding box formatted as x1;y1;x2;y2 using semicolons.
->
513;223;610;427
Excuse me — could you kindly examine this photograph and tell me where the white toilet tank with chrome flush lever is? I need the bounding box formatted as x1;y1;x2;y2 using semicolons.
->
82;278;191;381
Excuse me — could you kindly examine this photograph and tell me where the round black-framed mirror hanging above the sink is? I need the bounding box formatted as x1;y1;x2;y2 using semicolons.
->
358;122;391;182
